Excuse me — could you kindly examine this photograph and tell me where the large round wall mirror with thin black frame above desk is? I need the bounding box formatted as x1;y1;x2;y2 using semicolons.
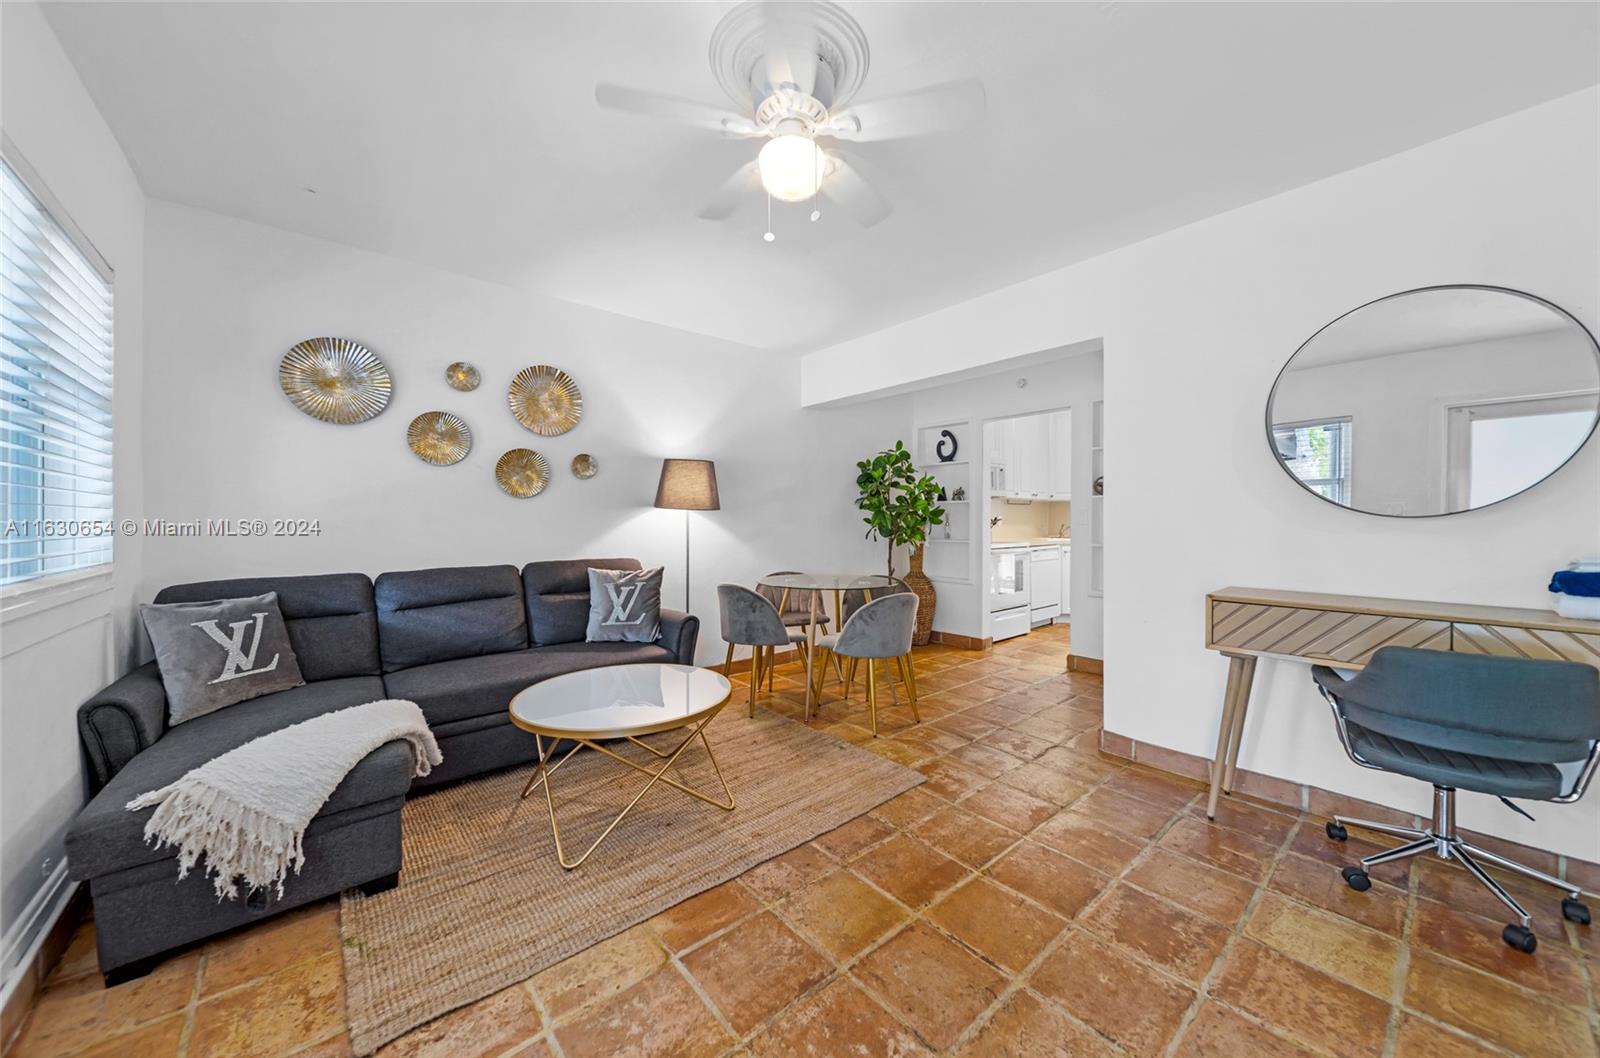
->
1267;287;1600;517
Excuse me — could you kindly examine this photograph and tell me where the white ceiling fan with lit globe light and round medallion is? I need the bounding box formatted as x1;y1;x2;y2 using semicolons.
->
595;0;986;242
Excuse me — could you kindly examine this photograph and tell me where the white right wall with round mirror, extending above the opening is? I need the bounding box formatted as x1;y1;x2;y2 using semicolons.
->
802;90;1600;860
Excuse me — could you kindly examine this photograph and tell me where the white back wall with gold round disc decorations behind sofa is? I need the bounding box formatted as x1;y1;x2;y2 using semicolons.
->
141;202;910;661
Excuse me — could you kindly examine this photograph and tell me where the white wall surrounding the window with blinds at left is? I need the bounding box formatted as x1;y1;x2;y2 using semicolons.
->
0;3;144;984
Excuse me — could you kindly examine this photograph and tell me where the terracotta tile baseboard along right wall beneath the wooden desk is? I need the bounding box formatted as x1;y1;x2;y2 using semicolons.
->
1099;728;1600;895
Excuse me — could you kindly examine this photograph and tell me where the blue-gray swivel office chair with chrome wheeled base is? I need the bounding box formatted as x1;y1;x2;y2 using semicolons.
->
1312;647;1600;952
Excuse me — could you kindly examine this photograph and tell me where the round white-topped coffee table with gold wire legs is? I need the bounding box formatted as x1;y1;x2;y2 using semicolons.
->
510;663;734;871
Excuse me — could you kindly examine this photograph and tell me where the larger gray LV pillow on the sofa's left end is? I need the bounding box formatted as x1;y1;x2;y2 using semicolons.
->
139;592;306;723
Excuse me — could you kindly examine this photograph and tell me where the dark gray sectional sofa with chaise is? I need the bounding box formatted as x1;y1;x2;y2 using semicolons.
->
66;559;699;983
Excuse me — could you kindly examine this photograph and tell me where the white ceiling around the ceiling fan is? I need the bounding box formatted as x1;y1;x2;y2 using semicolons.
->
46;3;1600;351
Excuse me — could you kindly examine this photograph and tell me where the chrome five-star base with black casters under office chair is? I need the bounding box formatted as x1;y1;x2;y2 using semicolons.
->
1326;786;1589;952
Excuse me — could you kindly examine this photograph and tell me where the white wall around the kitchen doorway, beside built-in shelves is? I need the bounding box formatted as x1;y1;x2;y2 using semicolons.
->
912;344;1104;658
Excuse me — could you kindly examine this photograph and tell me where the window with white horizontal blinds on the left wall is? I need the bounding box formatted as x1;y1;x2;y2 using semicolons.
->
0;160;114;584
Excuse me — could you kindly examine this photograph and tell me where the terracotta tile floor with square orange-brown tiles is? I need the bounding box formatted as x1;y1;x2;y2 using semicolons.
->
8;629;1600;1058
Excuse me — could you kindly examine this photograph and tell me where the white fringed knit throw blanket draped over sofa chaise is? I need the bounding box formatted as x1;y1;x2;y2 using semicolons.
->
128;698;442;900
